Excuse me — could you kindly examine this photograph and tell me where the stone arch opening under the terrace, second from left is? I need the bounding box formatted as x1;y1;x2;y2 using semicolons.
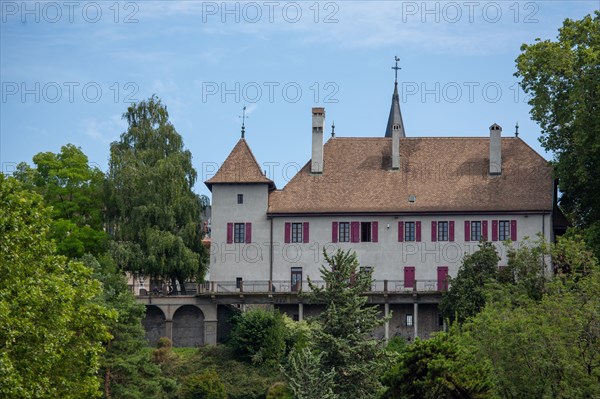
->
173;305;204;348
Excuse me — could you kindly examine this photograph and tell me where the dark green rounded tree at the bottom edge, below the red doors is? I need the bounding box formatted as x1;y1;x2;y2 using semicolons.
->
382;330;497;399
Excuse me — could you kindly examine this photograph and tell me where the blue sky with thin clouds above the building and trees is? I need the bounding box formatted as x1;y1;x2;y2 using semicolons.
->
0;0;600;198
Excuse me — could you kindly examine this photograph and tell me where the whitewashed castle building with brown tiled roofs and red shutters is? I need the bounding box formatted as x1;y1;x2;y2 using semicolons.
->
205;67;566;339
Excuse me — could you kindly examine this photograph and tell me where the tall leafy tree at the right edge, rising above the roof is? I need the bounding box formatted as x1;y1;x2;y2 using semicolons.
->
515;11;600;255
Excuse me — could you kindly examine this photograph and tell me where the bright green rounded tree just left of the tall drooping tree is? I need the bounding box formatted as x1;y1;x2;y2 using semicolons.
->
14;144;107;258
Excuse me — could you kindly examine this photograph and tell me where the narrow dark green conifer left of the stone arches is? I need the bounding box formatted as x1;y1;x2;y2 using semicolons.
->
82;254;175;399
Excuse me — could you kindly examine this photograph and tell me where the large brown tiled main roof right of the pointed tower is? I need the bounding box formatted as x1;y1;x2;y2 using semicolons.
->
268;137;553;214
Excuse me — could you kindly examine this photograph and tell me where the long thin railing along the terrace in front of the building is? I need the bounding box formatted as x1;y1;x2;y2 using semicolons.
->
135;280;449;296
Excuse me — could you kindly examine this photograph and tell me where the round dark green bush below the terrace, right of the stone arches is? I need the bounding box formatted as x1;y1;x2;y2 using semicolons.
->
229;308;286;365
